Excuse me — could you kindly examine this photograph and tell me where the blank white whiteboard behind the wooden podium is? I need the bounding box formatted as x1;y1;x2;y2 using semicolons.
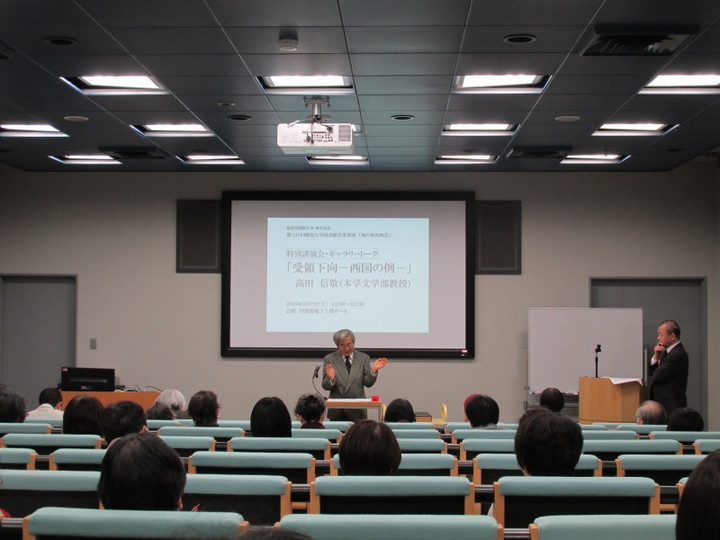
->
528;308;643;394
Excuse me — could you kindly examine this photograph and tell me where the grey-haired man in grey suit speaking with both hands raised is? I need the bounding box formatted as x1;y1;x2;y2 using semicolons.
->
322;328;387;422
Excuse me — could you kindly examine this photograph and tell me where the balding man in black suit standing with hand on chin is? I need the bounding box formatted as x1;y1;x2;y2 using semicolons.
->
649;320;689;417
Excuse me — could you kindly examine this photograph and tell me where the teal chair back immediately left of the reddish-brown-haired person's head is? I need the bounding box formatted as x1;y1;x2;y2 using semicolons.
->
188;452;315;484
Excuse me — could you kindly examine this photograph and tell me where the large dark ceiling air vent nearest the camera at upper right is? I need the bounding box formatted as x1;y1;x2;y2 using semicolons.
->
582;25;698;56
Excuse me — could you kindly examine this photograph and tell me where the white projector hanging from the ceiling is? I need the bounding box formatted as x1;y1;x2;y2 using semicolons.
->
277;122;355;155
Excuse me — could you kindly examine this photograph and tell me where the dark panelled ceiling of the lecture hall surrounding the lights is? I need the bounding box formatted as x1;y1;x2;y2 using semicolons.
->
0;0;720;172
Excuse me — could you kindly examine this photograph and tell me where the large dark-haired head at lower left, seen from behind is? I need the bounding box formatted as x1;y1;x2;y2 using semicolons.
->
98;432;185;510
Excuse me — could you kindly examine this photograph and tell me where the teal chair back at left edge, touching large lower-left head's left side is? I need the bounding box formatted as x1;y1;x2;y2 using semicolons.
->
0;470;100;517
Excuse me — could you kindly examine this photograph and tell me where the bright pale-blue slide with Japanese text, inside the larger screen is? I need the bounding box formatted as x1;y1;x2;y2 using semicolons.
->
266;218;430;332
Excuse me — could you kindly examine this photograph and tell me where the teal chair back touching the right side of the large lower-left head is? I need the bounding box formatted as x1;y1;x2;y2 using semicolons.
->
183;474;292;525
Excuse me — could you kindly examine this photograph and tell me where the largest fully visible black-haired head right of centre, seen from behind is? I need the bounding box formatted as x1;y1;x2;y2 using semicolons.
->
515;407;583;476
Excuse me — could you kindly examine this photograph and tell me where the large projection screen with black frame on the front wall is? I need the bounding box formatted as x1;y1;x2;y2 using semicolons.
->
221;191;475;358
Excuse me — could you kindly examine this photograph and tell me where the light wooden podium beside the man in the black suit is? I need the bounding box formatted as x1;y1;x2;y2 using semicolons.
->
578;377;644;424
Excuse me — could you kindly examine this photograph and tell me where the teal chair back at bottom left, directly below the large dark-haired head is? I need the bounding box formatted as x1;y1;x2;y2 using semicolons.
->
23;507;248;540
